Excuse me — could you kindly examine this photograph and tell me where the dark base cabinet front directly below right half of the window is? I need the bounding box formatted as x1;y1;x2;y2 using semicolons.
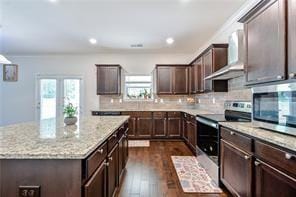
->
137;112;153;138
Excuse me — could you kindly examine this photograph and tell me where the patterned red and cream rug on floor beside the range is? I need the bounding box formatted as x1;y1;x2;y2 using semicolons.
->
171;156;222;193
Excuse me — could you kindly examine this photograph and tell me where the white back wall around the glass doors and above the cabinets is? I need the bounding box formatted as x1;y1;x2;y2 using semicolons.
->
1;54;191;125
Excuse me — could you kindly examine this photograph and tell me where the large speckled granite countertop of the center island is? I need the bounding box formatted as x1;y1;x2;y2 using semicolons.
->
0;116;129;159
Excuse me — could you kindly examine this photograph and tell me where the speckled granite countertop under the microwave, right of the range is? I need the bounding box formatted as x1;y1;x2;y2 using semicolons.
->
219;122;296;152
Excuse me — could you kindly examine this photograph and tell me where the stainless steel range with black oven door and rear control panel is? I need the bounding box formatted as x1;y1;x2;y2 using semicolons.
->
196;101;252;184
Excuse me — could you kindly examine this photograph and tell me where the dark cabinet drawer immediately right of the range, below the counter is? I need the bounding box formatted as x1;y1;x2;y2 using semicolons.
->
221;127;252;153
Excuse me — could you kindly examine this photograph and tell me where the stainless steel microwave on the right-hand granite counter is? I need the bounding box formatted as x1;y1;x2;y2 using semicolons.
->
252;83;296;136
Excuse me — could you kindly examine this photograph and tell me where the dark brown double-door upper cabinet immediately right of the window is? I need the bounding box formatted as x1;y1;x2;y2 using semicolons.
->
156;65;189;95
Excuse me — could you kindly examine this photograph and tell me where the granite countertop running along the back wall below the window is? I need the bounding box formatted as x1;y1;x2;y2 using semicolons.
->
92;108;214;116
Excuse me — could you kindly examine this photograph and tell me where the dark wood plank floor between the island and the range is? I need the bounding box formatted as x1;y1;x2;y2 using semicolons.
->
118;141;228;197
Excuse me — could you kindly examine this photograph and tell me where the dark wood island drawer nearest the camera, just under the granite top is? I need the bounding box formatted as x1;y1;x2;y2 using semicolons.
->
86;143;107;177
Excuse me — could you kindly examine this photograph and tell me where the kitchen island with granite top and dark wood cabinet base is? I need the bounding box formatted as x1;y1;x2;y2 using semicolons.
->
0;116;129;197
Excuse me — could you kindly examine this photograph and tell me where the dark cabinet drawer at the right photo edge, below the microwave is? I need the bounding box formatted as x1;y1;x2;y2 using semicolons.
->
255;141;296;177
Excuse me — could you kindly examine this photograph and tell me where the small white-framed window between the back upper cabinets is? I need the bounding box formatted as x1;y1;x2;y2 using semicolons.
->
124;75;153;99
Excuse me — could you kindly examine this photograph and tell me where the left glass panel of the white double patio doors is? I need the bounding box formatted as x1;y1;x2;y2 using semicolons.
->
38;79;57;120
